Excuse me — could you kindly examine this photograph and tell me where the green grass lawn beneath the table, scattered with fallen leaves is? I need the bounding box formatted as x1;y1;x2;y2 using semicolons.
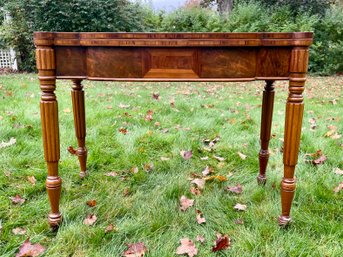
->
0;74;343;257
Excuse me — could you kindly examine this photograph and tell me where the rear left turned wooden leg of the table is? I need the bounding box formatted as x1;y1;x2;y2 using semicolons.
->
68;80;87;178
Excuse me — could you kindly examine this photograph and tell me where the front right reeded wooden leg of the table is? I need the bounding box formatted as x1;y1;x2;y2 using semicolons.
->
279;47;308;226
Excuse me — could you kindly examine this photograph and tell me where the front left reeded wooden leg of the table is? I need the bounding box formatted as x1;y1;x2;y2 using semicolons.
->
36;46;62;227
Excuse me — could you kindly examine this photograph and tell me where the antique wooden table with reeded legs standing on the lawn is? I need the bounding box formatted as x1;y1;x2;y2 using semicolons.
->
34;32;313;227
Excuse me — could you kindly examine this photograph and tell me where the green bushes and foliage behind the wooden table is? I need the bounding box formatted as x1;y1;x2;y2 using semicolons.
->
0;0;343;75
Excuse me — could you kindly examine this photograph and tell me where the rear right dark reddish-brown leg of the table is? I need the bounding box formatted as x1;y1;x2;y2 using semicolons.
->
257;80;275;184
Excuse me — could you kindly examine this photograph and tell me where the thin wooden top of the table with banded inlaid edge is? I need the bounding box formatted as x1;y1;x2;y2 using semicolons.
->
34;32;313;47
